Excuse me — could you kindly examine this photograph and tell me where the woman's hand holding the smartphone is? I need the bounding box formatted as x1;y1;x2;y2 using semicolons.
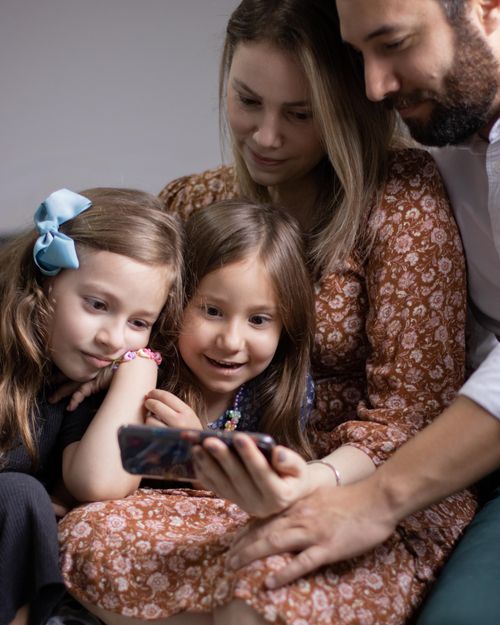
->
193;433;335;518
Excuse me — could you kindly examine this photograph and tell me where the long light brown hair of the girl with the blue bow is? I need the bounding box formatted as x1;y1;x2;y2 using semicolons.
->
0;188;182;464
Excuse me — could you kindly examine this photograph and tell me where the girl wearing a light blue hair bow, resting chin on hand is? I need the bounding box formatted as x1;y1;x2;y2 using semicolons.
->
0;188;182;625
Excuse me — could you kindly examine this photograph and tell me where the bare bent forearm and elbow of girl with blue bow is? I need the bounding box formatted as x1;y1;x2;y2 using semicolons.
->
63;358;157;501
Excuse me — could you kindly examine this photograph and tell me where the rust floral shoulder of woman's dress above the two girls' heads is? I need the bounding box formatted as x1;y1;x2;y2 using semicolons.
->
159;166;238;219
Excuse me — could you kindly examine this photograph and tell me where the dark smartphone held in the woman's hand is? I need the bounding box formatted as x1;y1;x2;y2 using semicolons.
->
118;425;275;482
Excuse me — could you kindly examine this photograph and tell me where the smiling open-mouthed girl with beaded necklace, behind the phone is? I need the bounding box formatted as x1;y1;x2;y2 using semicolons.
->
145;201;314;450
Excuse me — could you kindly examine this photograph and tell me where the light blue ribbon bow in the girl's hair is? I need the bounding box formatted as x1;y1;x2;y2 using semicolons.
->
33;189;92;276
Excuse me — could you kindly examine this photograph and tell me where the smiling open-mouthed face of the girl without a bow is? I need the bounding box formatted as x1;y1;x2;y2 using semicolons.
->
179;254;282;410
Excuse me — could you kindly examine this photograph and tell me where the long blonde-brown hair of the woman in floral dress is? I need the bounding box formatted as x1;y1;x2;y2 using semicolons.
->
219;0;397;275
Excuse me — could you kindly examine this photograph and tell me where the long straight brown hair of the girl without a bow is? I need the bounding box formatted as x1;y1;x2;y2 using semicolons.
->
165;200;315;454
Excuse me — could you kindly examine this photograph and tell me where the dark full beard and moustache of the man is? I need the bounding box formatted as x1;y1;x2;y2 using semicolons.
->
387;17;500;146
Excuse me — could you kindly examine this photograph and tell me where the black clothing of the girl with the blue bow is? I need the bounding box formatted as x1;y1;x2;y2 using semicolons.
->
0;395;102;625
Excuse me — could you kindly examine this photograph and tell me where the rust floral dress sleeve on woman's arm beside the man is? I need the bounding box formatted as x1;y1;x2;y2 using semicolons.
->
335;150;466;464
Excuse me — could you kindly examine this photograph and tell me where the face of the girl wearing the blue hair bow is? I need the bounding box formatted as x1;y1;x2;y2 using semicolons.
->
49;250;171;382
